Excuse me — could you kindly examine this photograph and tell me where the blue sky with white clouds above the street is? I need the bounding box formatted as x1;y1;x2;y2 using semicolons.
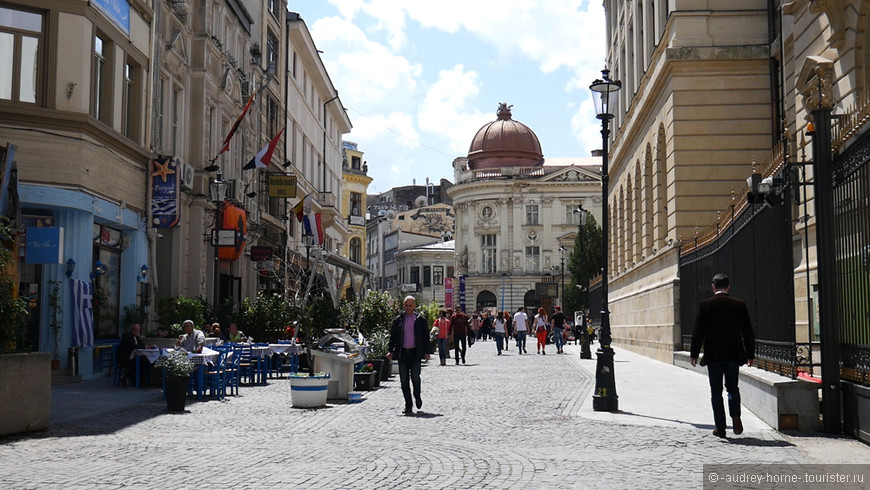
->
288;0;605;193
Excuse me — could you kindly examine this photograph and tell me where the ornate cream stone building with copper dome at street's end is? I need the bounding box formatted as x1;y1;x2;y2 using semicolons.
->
447;103;601;318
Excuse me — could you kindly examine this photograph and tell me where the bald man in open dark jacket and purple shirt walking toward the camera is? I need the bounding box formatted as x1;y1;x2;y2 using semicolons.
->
387;296;429;415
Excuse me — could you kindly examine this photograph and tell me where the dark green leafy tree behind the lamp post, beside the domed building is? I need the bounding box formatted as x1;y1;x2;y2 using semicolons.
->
564;213;603;315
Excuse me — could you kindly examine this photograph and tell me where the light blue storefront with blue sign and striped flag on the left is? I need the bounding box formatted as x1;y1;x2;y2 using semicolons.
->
18;184;148;378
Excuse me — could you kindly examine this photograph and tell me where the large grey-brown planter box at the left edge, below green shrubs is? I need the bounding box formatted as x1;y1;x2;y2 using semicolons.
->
0;352;51;436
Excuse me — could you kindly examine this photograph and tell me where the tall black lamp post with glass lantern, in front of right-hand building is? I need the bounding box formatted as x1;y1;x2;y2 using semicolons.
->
589;69;622;412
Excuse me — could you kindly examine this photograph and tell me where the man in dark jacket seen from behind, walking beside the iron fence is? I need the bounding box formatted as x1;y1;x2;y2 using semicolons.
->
691;274;755;438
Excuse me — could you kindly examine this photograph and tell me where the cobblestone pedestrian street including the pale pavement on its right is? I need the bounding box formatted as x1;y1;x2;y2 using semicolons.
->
0;341;870;489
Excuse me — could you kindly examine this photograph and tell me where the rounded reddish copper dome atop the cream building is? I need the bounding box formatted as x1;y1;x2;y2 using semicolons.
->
468;102;544;170
